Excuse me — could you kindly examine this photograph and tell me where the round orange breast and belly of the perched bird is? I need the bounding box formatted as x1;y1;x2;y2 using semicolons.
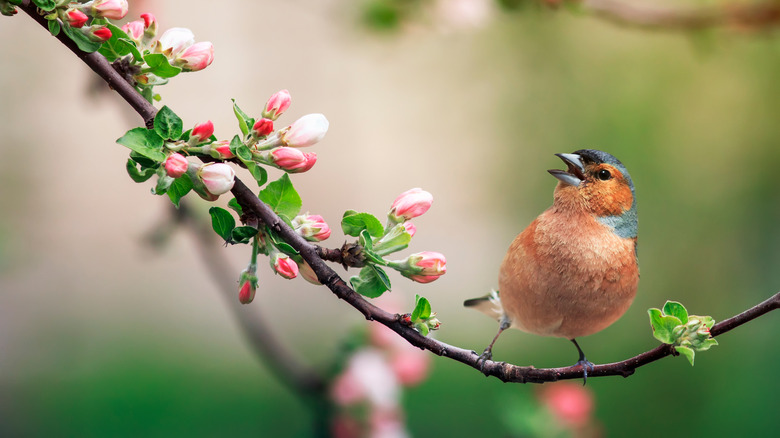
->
499;206;639;339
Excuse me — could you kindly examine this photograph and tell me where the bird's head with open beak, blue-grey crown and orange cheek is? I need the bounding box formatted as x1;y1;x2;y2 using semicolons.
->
548;149;637;238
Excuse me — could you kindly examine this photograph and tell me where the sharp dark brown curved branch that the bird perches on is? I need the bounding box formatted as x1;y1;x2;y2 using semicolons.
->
22;0;780;383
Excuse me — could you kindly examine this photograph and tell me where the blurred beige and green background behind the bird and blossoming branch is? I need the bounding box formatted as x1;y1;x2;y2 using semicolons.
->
0;0;780;437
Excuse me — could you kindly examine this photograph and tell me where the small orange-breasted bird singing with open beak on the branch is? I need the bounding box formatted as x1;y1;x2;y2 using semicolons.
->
463;149;639;384
